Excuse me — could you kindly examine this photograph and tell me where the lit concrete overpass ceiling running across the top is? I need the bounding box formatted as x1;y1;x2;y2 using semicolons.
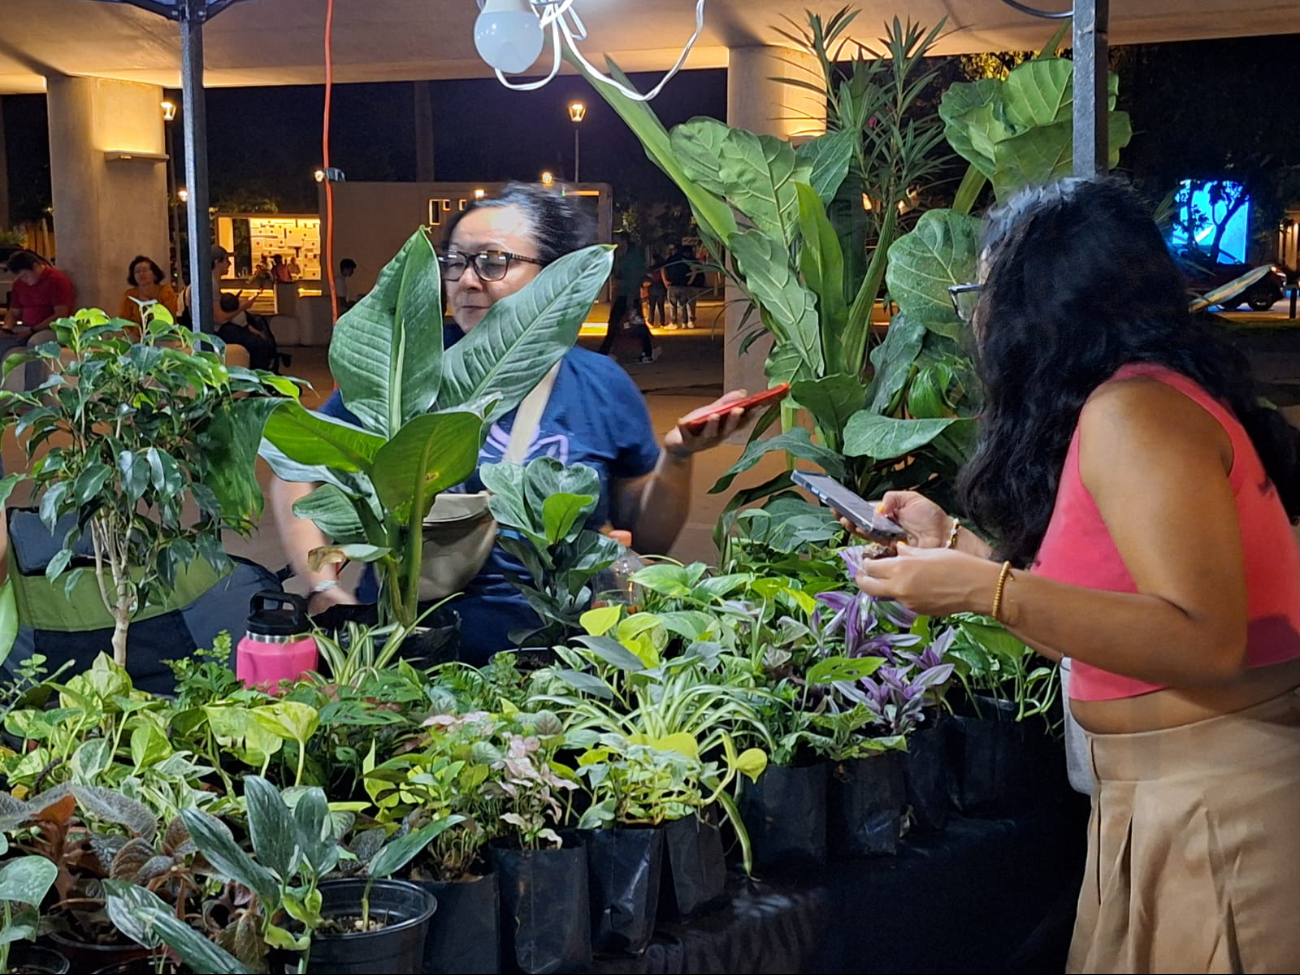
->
0;0;1297;94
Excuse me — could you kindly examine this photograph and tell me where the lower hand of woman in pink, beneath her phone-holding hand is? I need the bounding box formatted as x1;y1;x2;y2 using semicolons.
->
854;543;1001;616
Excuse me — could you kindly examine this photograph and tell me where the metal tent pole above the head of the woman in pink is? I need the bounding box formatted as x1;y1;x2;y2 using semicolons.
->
1073;0;1110;177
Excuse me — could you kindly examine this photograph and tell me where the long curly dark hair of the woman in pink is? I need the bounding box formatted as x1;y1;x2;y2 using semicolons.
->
959;178;1300;566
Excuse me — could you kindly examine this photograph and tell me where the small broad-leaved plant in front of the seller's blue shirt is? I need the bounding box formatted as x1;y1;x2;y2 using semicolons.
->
482;458;620;647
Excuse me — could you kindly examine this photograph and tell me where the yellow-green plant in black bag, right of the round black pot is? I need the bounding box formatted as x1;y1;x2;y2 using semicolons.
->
364;711;504;974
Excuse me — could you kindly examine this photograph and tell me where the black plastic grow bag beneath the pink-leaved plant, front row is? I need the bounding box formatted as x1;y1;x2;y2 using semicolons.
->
493;837;592;975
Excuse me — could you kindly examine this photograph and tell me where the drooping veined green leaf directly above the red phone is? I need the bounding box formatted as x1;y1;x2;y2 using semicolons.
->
728;230;824;377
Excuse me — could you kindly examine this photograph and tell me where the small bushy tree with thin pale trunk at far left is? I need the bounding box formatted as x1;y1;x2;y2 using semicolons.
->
0;306;296;667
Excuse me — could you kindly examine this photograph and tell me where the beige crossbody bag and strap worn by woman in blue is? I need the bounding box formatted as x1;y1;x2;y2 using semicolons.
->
420;363;560;602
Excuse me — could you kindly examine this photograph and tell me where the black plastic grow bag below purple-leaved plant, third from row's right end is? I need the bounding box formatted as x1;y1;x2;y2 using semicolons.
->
828;751;905;857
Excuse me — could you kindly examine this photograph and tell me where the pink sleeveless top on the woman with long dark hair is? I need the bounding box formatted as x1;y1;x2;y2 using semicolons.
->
1034;364;1300;701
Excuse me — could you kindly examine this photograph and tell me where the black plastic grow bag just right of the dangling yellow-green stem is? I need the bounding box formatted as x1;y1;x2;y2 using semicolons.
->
740;762;831;871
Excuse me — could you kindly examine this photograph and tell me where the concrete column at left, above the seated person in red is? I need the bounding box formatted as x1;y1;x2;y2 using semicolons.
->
47;77;168;315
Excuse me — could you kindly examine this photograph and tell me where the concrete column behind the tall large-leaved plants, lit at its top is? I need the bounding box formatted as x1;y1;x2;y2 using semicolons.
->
724;47;826;393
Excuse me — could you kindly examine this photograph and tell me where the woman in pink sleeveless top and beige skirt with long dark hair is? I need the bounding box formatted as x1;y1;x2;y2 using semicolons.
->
837;179;1300;972
